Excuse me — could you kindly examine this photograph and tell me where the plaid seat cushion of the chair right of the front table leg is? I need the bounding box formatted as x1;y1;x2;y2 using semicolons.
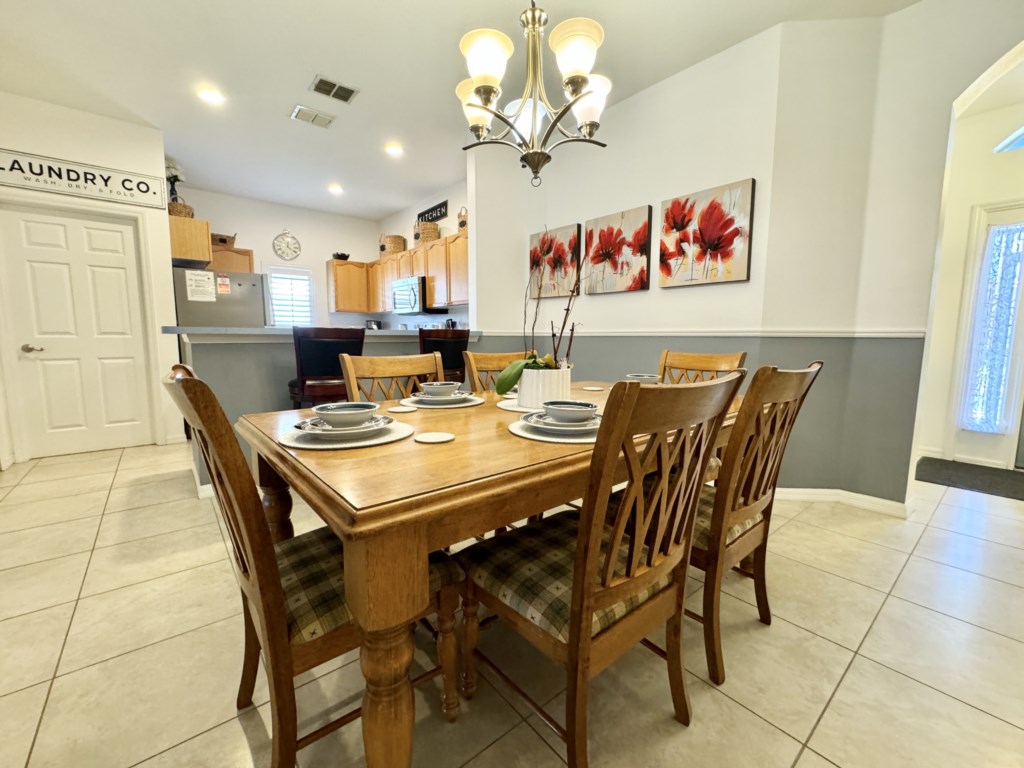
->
457;511;672;643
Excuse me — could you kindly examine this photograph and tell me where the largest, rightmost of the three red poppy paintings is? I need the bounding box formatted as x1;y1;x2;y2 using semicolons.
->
658;178;754;288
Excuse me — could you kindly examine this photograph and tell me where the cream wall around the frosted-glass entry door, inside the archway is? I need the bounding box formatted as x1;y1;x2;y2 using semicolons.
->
915;103;1024;458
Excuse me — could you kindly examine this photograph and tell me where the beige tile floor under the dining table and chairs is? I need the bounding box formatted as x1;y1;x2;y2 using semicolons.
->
0;445;1024;768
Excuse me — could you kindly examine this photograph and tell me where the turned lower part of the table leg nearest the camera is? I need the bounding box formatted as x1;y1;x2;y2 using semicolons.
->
359;624;416;768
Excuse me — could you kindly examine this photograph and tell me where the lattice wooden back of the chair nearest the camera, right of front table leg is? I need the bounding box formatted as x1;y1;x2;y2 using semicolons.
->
569;372;745;647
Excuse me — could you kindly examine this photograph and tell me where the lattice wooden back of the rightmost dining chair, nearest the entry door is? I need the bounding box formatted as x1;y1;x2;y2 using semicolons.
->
708;360;823;559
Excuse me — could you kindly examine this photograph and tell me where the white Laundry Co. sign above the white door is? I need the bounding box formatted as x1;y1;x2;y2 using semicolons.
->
0;150;166;208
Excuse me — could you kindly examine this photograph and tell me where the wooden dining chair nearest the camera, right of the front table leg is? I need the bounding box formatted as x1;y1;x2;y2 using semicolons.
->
457;372;743;768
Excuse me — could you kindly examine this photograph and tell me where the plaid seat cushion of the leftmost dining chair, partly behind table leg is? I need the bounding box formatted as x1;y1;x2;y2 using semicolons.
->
273;527;465;645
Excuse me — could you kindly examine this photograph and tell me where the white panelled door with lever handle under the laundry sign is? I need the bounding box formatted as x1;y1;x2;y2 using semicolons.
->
0;209;153;458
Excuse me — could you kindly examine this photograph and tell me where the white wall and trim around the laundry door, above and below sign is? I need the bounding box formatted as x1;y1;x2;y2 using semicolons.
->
0;93;183;463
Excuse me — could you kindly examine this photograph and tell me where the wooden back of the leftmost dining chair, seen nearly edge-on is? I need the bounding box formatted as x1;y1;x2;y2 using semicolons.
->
164;365;290;667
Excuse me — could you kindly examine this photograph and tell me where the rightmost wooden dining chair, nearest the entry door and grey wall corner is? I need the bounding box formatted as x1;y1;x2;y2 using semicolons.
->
686;361;823;685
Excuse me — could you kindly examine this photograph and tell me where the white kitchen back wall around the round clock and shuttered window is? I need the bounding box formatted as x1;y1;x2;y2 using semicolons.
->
178;190;380;327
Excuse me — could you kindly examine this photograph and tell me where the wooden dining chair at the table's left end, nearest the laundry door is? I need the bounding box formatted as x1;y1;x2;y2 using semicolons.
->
164;365;464;768
